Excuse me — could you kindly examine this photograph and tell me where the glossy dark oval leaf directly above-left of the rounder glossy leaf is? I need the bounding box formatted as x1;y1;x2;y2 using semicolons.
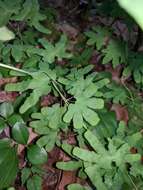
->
12;122;29;144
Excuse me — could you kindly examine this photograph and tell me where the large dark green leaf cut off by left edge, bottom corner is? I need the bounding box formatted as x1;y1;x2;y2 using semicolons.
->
0;139;18;189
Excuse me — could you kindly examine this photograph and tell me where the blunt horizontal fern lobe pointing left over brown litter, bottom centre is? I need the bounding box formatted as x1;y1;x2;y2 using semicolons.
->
56;161;82;171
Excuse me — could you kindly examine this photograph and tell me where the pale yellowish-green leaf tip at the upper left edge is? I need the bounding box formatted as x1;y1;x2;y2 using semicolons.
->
0;26;15;42
